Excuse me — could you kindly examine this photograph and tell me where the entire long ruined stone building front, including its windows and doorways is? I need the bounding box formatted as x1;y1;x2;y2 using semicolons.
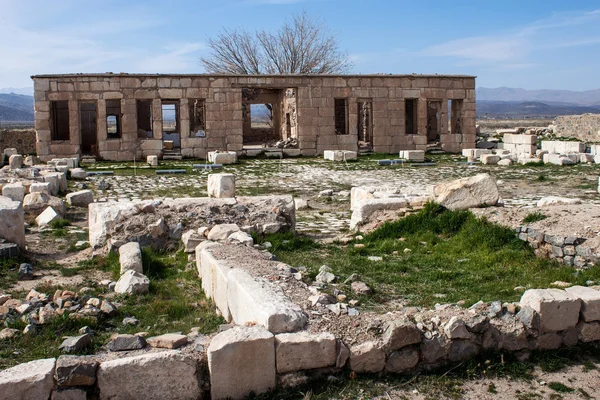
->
32;73;475;160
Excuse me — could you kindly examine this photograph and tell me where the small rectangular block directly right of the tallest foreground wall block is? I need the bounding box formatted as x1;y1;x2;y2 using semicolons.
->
275;332;337;374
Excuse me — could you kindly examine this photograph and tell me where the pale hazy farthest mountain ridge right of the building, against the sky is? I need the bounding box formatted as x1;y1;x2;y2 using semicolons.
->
476;87;600;106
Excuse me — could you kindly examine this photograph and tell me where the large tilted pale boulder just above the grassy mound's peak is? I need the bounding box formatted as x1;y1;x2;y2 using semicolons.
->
433;174;499;210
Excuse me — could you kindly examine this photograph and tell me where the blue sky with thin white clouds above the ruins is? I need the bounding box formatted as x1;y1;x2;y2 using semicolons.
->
0;0;600;90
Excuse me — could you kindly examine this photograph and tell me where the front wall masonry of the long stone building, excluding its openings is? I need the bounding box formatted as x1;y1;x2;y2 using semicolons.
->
33;74;475;160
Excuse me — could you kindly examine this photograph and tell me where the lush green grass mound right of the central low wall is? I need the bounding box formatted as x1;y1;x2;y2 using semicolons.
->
265;204;600;307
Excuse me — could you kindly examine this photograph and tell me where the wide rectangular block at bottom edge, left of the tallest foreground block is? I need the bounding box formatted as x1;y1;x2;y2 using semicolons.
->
97;351;202;400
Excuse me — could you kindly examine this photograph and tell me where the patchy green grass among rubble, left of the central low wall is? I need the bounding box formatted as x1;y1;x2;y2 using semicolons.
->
0;249;225;370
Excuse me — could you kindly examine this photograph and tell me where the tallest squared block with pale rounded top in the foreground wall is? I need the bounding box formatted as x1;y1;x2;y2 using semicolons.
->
207;326;276;400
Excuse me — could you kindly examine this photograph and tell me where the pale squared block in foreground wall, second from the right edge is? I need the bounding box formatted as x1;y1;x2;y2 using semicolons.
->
521;289;581;332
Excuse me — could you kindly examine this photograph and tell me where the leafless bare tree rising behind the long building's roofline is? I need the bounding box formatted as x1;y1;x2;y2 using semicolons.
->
200;12;352;75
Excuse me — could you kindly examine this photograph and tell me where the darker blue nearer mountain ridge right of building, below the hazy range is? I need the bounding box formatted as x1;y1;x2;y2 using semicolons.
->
477;99;600;118
